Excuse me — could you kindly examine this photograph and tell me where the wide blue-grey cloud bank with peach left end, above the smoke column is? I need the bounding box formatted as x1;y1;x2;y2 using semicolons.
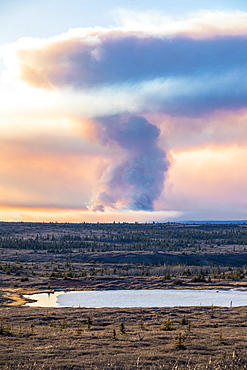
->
2;13;247;115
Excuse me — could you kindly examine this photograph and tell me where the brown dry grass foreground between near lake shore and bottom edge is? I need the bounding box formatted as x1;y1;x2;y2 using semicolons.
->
0;306;247;370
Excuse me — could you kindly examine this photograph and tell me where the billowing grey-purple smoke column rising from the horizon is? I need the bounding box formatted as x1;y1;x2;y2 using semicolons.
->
92;116;169;211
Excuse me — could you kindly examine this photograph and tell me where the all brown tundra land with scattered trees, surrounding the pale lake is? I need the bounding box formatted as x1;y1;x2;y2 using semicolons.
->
0;223;247;370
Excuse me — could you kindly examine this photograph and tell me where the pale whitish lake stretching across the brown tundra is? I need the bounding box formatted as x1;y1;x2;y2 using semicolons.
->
24;289;247;308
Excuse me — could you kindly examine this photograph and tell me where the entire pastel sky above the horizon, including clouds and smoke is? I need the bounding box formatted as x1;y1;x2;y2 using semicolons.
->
0;0;247;222
